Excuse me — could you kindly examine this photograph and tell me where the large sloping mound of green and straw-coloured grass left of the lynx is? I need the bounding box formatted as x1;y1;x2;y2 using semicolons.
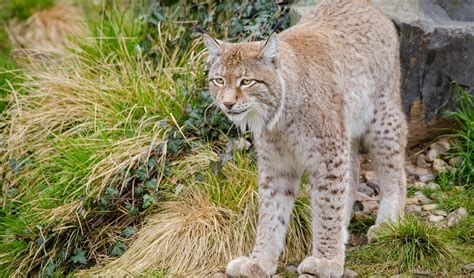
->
0;3;213;274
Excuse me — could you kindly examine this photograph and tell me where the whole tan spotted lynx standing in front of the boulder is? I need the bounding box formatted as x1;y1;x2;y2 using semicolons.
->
204;0;406;277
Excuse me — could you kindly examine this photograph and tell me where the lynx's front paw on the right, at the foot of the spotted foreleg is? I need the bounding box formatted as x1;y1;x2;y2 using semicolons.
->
298;257;344;278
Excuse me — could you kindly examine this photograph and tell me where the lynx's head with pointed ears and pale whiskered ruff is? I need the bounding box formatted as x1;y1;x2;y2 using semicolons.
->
203;34;283;132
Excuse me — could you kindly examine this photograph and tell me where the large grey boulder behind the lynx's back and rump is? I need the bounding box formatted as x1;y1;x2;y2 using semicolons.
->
291;0;474;146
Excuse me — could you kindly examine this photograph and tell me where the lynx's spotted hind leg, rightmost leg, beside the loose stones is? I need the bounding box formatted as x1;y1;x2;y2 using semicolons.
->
365;104;406;240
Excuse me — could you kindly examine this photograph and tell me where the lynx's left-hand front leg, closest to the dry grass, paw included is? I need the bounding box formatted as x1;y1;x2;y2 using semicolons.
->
226;165;299;277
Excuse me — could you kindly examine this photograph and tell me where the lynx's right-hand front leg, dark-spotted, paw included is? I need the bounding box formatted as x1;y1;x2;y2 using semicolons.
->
298;138;350;277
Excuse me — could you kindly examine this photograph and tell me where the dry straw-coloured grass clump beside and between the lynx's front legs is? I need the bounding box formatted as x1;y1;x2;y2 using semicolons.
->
83;149;311;276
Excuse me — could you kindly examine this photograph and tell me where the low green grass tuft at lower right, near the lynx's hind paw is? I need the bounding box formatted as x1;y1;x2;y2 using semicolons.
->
347;215;459;274
